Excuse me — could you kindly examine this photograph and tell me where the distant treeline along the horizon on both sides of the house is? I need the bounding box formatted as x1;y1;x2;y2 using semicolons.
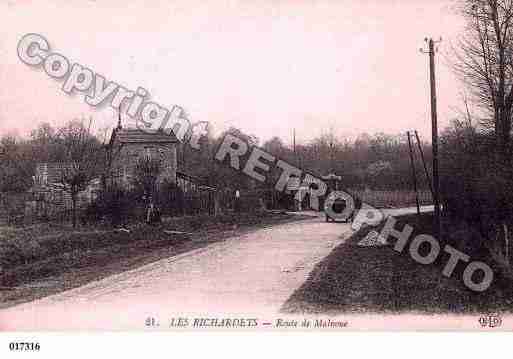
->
0;121;431;192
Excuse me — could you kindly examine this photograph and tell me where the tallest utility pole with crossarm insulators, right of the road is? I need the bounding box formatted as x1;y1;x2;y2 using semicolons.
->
421;38;442;240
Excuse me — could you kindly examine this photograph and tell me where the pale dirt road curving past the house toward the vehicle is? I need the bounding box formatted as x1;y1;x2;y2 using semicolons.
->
0;212;351;330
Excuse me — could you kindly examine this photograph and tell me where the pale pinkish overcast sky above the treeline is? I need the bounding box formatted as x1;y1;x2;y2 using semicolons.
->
0;0;463;143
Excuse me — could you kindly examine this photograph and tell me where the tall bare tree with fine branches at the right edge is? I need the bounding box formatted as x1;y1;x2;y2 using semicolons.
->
454;0;513;158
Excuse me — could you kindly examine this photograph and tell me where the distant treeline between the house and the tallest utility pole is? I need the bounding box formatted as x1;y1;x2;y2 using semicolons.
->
178;128;431;190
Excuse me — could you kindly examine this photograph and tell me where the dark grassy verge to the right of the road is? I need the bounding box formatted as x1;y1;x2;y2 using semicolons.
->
282;215;513;313
